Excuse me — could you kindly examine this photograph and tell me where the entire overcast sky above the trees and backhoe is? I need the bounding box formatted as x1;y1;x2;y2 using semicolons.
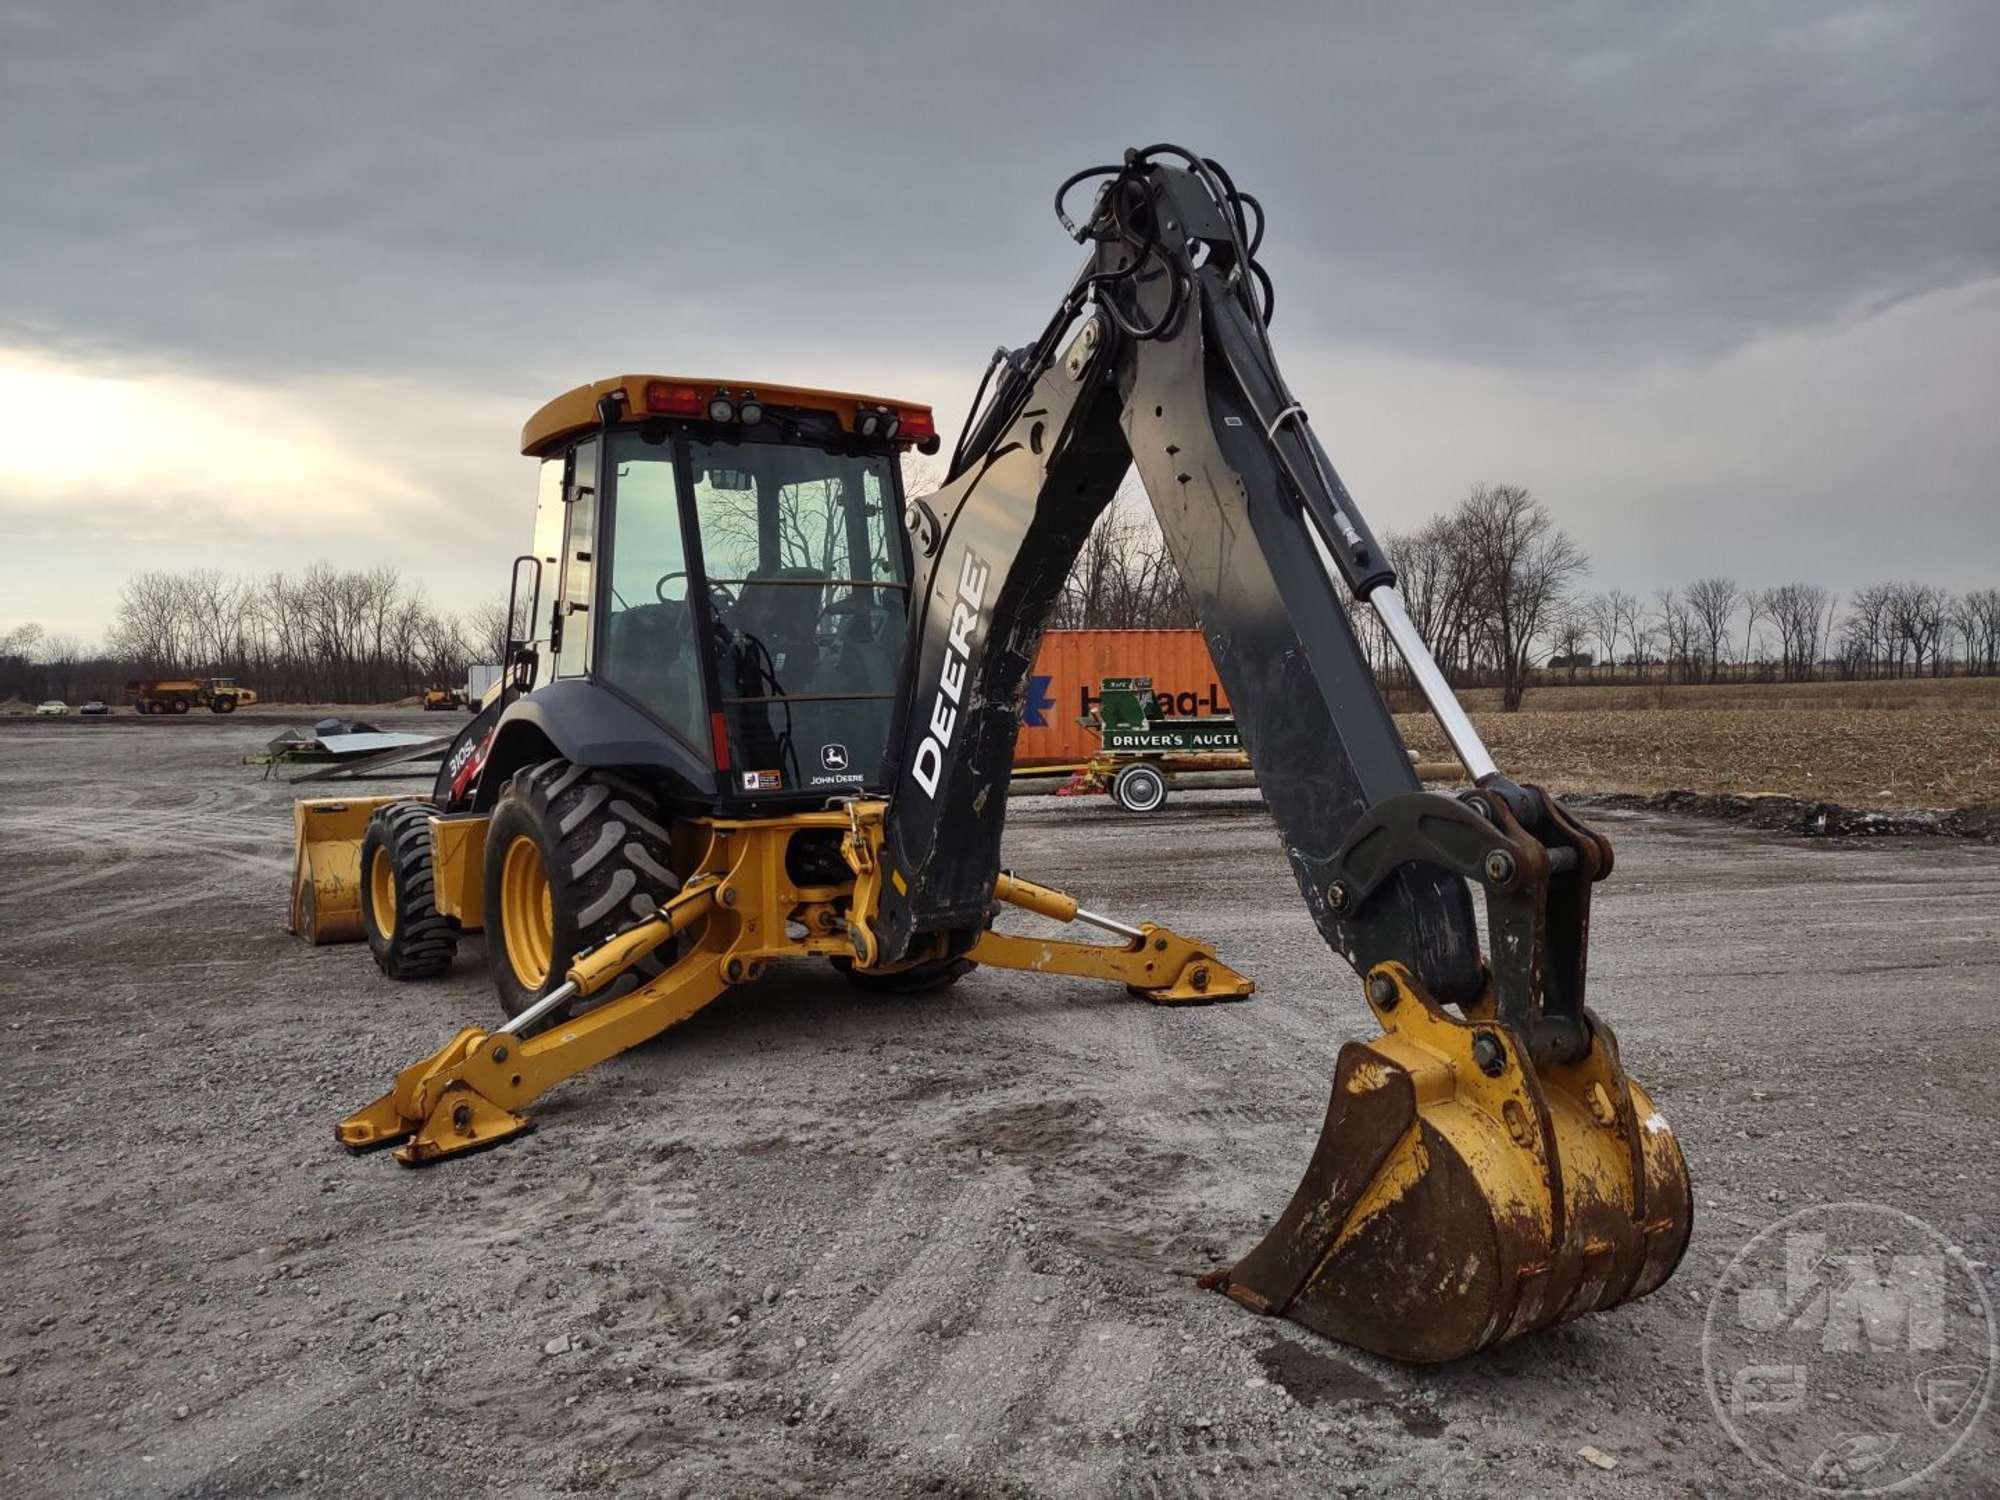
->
0;0;2000;640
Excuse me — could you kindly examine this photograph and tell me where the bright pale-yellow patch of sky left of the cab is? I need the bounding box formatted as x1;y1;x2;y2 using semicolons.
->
0;348;532;638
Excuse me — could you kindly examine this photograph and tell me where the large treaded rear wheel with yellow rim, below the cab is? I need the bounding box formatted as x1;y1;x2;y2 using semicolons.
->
486;760;680;1030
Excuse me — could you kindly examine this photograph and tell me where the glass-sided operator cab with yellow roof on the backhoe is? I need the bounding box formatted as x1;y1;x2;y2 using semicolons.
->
502;376;938;812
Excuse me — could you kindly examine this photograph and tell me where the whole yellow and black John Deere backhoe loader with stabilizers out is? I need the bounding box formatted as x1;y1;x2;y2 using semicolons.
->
292;144;1692;1362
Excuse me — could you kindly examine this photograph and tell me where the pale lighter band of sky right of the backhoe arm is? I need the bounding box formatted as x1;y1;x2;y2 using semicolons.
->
1292;278;2000;592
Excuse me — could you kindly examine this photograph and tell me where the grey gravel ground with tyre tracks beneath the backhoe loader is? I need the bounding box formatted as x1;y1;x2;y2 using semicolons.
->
0;714;2000;1496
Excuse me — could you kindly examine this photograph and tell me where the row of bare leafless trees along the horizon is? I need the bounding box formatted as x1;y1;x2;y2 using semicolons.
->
0;476;2000;710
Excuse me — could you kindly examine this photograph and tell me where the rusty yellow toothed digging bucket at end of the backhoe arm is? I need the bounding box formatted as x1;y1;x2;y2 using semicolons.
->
1204;964;1692;1364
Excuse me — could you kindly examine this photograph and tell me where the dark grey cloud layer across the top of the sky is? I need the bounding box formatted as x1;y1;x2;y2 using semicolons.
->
0;2;2000;368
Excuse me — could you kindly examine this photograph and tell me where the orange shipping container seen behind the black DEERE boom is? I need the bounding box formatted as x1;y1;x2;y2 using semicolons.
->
1014;630;1230;766
